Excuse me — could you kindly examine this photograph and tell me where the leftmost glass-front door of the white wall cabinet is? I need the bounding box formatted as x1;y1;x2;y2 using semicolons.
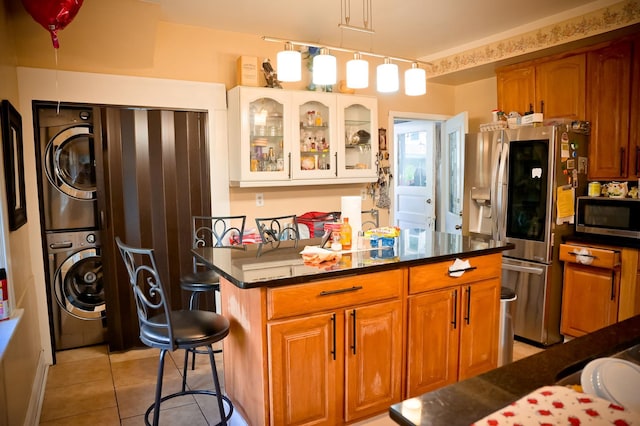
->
229;88;291;182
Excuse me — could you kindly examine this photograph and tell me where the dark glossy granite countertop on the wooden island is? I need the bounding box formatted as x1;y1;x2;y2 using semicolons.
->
192;229;513;288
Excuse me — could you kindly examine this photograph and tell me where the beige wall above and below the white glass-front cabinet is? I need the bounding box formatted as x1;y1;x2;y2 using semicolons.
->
7;0;457;230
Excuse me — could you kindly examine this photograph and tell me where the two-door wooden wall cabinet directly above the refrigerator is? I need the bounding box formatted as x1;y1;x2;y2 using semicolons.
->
497;54;586;120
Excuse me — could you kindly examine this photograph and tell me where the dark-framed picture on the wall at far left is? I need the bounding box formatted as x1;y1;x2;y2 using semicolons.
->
0;99;27;231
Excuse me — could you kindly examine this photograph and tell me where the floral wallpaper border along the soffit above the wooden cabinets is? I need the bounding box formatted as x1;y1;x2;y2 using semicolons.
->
429;0;640;77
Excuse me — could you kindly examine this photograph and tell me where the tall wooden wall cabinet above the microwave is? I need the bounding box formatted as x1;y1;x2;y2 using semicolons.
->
586;41;640;180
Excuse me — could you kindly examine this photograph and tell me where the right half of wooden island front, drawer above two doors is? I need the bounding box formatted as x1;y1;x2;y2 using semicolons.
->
407;255;502;397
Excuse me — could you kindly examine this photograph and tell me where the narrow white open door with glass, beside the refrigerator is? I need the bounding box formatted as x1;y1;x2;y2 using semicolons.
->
438;111;468;234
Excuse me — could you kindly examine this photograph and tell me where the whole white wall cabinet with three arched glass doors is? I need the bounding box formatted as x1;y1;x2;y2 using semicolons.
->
228;86;378;187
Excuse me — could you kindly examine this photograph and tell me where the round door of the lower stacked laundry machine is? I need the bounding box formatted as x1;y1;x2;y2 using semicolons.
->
54;248;106;320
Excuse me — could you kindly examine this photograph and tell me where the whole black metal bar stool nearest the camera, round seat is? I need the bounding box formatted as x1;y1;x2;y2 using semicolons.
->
116;237;233;426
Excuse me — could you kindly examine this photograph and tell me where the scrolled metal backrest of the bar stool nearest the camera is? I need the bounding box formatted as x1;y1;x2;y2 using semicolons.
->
116;237;176;350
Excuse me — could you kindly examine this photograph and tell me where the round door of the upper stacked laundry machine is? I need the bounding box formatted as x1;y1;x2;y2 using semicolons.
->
44;124;96;200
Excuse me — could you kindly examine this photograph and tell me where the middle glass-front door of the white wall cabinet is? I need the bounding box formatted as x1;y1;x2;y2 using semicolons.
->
291;92;338;179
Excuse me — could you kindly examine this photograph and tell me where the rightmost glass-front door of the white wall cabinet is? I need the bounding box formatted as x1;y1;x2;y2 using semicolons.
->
338;96;378;177
